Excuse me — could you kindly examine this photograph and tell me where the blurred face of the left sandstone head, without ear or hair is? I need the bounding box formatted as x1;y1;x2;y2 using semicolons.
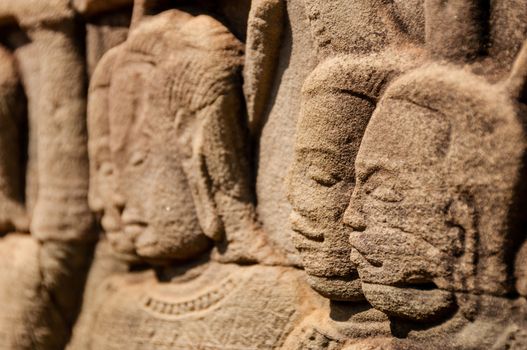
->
103;53;209;260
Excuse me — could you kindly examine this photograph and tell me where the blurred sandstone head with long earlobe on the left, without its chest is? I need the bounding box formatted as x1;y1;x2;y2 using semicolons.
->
90;4;276;261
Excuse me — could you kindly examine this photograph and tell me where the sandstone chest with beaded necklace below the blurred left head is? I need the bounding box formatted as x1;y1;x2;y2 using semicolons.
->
80;263;315;349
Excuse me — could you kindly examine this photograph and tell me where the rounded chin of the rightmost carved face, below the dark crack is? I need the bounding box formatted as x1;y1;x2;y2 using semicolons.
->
362;282;455;321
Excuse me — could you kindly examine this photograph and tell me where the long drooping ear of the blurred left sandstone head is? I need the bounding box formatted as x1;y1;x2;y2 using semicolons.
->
175;84;254;241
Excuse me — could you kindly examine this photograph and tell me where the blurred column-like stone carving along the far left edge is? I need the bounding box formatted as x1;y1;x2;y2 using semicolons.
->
0;1;94;349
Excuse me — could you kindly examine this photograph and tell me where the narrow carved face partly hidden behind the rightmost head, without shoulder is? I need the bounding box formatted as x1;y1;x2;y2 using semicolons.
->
288;59;388;300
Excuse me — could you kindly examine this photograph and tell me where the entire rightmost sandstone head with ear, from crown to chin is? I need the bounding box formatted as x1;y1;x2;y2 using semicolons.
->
344;65;521;320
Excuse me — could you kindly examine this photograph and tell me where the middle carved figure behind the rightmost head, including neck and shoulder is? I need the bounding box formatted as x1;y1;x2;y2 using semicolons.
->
287;49;428;349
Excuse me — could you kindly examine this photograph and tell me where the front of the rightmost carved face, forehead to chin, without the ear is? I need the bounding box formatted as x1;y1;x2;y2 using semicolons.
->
346;93;460;320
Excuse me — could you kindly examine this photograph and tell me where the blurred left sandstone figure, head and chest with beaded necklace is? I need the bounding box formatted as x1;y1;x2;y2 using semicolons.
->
69;3;321;349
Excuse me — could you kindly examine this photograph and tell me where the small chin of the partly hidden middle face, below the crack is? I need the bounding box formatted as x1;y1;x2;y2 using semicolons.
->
307;275;364;301
